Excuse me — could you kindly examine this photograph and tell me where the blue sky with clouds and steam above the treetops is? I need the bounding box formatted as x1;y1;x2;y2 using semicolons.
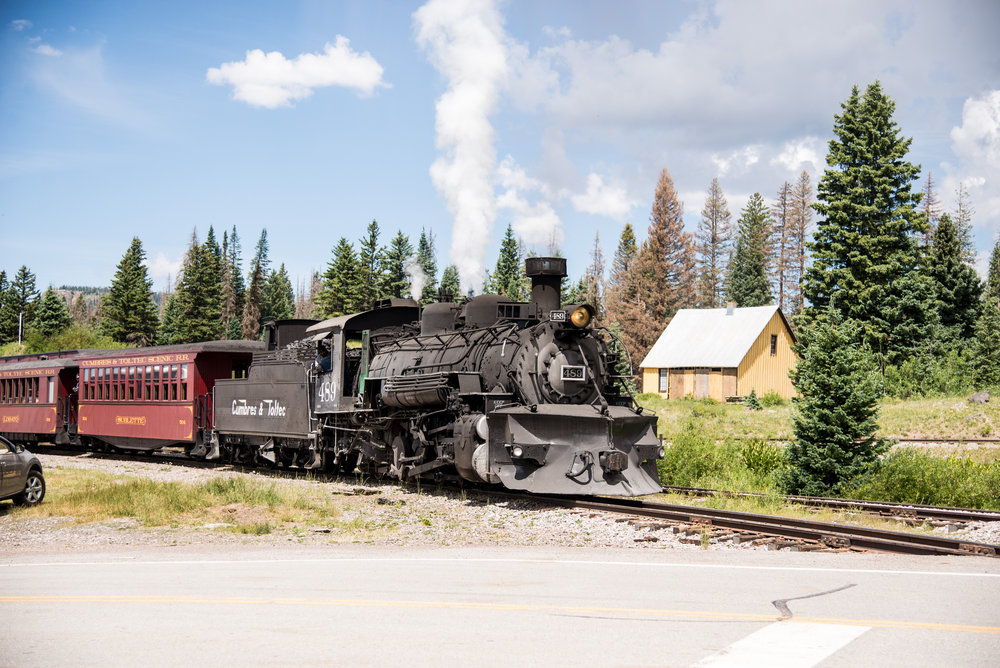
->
0;0;1000;290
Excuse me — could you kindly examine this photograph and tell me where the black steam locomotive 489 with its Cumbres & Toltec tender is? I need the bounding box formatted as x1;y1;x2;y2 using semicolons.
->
210;258;663;495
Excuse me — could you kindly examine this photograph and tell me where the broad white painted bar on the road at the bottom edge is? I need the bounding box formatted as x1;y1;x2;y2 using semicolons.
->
694;621;870;668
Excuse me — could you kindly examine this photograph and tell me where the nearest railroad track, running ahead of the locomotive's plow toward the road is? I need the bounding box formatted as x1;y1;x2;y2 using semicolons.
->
533;496;1000;557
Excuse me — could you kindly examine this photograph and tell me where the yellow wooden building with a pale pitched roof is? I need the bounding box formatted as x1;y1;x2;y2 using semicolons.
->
640;306;796;401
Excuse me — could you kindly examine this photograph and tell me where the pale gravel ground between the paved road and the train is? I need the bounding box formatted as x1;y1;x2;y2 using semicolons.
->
0;454;1000;554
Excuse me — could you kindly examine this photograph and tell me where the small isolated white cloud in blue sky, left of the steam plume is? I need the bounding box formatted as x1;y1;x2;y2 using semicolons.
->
206;35;388;109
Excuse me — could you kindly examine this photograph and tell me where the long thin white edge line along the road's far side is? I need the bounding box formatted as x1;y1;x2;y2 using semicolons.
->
6;557;1000;578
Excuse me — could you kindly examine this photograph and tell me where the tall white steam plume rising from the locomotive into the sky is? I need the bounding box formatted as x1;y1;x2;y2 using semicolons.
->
413;0;508;291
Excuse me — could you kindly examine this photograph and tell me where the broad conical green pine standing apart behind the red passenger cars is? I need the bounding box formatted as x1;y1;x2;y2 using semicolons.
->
101;237;160;346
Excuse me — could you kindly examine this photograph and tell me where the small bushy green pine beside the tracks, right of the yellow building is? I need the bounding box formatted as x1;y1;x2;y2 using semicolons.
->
781;307;890;496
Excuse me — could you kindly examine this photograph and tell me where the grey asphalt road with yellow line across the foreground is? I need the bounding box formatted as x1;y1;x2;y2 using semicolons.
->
0;545;1000;668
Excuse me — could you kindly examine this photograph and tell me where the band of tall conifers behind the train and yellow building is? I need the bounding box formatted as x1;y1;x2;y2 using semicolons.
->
0;83;1000;396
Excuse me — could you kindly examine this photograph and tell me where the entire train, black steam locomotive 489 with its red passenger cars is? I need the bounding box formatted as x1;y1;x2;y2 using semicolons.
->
0;258;663;496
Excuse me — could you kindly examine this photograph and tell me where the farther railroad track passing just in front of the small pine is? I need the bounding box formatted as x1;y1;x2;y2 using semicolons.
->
663;485;1000;524
